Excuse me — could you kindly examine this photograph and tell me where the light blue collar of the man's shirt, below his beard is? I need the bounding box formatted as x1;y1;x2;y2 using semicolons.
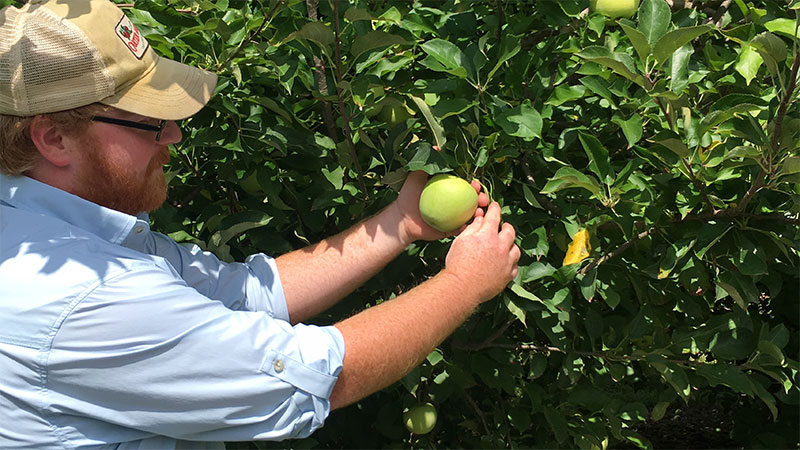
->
0;174;147;244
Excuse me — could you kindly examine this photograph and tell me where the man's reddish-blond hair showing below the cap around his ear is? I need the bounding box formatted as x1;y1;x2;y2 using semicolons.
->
0;103;108;175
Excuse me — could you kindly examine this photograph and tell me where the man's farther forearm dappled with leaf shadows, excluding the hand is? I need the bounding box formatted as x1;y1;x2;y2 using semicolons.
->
276;204;408;323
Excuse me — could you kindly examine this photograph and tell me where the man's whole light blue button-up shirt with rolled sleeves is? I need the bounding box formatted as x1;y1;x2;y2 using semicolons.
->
0;175;344;449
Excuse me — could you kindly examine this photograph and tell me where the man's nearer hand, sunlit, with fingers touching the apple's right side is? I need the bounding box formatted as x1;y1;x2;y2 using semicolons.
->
445;202;520;301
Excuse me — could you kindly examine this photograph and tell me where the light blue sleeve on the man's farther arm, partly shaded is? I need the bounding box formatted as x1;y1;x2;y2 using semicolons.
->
146;232;289;321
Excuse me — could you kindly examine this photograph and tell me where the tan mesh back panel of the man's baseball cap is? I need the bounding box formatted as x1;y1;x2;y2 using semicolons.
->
0;7;114;115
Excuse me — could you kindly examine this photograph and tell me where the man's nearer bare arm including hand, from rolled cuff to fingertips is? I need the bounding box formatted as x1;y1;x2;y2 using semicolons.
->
331;203;520;408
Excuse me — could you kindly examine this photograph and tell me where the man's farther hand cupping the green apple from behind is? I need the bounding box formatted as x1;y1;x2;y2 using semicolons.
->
392;171;489;244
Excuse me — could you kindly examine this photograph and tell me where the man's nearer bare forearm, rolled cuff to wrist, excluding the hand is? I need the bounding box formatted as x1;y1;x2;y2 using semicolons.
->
331;271;478;408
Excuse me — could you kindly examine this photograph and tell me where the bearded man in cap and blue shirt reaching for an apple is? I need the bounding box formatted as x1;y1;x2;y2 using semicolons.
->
0;0;520;448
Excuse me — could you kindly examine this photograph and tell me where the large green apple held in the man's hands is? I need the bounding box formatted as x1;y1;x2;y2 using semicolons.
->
419;174;478;233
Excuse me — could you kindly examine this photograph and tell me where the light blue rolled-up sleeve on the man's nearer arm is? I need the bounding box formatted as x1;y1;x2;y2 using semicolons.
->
46;263;344;441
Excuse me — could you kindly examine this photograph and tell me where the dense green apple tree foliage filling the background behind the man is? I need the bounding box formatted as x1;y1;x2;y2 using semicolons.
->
7;0;800;449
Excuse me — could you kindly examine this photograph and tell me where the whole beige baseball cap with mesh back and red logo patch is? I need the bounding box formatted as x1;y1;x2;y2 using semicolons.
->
0;0;217;120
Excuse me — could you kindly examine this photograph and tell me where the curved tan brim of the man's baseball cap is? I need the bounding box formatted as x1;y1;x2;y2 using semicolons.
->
100;56;217;120
